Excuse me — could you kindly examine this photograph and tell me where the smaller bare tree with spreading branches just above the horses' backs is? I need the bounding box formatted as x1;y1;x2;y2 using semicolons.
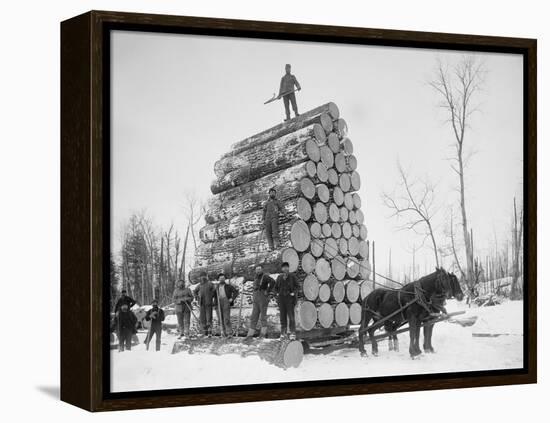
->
382;162;439;267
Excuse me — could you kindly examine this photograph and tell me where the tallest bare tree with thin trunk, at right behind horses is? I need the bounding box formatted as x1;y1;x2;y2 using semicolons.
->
429;56;484;283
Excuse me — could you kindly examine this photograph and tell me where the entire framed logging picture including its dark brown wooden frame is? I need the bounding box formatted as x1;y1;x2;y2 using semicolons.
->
61;11;537;411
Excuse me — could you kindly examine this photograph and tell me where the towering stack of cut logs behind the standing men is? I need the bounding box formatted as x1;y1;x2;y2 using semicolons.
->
189;103;372;331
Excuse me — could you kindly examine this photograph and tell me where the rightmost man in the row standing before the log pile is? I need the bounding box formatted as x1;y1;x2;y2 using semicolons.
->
273;262;298;339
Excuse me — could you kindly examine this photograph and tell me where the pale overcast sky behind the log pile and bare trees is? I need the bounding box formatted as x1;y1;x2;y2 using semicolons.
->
111;31;523;277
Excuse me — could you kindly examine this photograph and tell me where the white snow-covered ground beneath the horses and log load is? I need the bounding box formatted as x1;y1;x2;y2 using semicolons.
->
111;301;523;392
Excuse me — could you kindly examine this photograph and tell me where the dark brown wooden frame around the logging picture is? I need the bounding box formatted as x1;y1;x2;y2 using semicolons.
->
61;11;537;411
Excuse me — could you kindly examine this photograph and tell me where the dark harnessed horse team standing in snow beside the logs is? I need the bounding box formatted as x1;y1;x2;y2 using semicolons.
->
359;268;464;358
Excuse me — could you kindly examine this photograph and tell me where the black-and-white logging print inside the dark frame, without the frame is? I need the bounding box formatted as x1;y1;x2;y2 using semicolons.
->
108;30;525;393
